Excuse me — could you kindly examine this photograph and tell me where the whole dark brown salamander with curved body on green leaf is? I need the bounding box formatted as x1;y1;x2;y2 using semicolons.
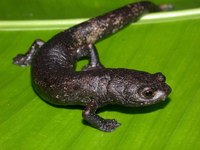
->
13;1;171;132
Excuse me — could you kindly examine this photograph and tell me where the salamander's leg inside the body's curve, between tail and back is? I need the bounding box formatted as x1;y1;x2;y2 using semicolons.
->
82;44;104;71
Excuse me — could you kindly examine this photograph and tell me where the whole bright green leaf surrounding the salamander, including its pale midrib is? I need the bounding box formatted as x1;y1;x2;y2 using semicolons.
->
0;0;200;150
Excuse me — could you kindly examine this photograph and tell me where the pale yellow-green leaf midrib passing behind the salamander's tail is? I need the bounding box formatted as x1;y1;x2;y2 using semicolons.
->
0;8;200;31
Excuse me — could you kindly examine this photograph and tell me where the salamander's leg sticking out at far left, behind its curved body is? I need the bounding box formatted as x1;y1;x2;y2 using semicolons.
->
13;39;44;66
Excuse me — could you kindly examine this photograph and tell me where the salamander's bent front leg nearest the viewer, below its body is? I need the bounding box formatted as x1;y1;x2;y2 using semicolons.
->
82;100;120;132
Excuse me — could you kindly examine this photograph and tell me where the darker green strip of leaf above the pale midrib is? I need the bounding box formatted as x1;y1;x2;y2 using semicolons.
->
0;0;200;20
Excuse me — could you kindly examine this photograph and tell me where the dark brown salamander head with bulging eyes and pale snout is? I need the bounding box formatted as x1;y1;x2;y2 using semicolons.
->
108;72;171;107
